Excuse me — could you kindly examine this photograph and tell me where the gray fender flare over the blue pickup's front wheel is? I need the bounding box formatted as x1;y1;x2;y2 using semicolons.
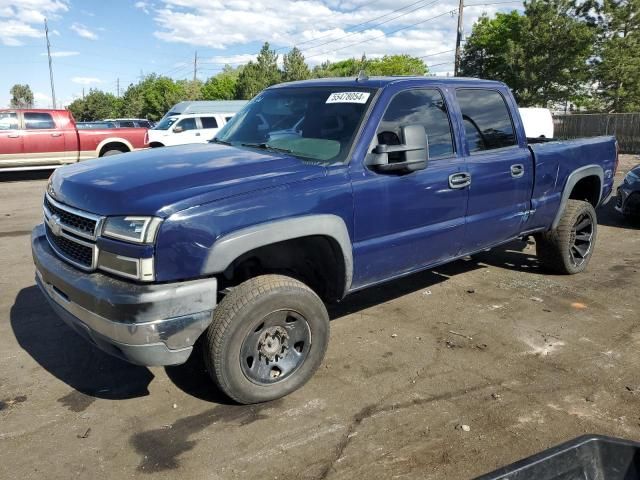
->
203;214;353;294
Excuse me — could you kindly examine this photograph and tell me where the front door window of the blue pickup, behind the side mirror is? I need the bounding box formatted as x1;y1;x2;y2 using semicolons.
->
378;89;454;162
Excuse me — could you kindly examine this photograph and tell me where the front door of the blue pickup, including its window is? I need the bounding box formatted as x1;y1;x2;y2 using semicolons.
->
351;88;468;288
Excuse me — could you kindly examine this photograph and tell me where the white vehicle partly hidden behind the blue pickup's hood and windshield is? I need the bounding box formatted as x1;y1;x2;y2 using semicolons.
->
147;113;234;148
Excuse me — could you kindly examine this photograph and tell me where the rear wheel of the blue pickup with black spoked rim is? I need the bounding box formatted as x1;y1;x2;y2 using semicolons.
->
536;200;598;275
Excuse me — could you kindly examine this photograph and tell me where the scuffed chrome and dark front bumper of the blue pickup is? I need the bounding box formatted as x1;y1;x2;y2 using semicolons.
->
31;225;217;366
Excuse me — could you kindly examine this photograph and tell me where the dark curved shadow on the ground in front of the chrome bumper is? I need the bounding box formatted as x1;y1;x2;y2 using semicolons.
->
10;285;154;403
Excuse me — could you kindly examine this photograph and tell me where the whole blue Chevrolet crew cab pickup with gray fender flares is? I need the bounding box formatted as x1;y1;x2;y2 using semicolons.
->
31;76;618;403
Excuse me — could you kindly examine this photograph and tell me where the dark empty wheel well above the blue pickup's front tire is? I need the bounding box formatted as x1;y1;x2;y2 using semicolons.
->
220;235;345;302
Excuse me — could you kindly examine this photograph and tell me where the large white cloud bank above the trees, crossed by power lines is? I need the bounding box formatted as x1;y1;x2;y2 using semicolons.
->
151;0;521;71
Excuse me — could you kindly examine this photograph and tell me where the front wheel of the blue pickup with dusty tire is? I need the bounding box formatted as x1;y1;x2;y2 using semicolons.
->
203;275;329;404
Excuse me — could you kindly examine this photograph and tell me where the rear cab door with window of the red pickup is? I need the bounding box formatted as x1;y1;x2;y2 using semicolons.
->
23;112;67;165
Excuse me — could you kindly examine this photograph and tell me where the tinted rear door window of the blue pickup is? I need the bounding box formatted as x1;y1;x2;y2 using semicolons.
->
456;89;517;152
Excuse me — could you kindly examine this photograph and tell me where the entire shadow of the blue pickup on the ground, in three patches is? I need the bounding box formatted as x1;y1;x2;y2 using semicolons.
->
10;241;539;402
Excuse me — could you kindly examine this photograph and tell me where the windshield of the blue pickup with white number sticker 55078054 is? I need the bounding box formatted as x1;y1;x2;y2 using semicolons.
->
213;87;375;163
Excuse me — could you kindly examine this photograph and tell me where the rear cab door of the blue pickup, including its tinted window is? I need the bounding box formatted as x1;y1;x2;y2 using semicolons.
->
456;88;533;252
